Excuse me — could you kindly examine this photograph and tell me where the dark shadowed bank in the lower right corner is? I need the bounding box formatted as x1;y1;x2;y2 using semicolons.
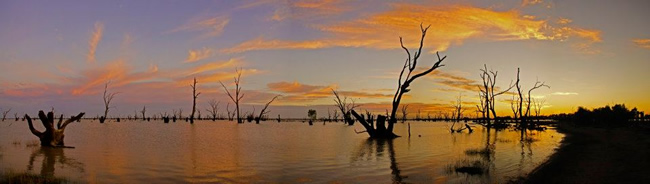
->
511;124;650;183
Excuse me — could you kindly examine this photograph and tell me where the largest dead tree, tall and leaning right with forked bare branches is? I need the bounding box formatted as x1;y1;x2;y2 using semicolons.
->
352;25;447;138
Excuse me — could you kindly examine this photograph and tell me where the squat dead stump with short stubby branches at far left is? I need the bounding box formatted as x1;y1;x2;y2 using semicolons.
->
25;111;85;148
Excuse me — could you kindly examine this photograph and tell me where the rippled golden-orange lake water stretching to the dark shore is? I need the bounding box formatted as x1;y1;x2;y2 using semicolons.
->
0;120;564;183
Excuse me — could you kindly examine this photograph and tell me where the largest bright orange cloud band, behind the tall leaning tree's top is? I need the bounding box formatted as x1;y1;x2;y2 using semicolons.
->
221;4;601;53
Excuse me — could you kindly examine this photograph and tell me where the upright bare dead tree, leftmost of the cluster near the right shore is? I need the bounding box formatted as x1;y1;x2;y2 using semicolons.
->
479;65;514;126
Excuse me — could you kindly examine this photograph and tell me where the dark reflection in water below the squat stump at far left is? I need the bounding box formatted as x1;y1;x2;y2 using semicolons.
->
27;147;84;176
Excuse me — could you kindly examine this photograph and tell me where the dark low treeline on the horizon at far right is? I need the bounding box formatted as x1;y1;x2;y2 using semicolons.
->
550;104;650;126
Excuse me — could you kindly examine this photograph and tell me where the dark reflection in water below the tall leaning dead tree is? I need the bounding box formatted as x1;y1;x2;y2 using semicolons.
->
353;138;407;183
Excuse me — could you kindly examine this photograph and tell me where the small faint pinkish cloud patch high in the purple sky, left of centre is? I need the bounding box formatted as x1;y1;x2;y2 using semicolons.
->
168;16;230;38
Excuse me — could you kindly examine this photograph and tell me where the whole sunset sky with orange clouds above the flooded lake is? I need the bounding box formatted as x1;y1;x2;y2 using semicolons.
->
0;0;650;118
